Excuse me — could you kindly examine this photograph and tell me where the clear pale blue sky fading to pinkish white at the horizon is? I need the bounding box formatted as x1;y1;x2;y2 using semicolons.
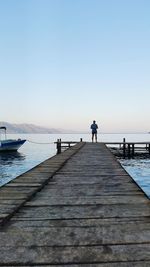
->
0;0;150;132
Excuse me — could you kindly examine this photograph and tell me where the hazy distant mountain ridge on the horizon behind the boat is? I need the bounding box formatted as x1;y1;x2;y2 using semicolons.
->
0;121;61;134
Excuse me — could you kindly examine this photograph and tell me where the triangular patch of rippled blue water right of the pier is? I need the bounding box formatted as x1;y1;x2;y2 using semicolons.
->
120;159;150;198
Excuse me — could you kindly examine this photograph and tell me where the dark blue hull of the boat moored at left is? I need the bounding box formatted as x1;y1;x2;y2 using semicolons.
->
0;140;26;152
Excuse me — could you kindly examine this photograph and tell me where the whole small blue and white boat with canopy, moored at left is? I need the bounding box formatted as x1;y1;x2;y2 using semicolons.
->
0;126;26;152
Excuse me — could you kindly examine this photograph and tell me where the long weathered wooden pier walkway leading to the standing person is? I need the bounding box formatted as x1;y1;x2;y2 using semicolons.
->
0;142;150;267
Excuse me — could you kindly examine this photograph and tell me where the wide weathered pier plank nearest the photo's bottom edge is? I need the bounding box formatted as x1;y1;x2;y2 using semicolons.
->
0;244;150;265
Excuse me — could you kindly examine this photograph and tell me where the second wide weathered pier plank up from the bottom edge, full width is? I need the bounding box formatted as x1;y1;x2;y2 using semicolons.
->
0;223;150;247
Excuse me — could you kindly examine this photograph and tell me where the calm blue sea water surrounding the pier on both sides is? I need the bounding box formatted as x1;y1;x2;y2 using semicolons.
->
0;133;150;197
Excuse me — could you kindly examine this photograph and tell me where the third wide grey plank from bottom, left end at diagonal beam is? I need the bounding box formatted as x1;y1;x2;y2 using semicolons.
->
16;204;150;220
